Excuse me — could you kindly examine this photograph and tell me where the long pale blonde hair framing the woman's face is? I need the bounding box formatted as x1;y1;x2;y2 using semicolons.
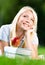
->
10;6;37;38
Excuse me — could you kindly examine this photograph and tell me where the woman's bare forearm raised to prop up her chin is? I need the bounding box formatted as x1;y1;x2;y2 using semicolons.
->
25;31;38;58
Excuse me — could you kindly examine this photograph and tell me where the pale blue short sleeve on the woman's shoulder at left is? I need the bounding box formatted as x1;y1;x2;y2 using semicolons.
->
0;25;9;42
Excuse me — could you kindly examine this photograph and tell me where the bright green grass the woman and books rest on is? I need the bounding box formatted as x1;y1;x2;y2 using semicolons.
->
0;47;45;65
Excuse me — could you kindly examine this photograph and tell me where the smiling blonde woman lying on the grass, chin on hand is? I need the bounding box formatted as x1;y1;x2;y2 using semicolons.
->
0;6;38;58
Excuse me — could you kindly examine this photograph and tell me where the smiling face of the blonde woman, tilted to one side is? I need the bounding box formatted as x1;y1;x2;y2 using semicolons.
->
18;10;34;30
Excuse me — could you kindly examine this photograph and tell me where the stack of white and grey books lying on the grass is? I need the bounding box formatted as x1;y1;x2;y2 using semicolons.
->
4;46;31;58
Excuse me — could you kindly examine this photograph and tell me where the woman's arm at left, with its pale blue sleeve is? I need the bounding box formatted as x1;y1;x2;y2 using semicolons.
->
0;25;10;53
